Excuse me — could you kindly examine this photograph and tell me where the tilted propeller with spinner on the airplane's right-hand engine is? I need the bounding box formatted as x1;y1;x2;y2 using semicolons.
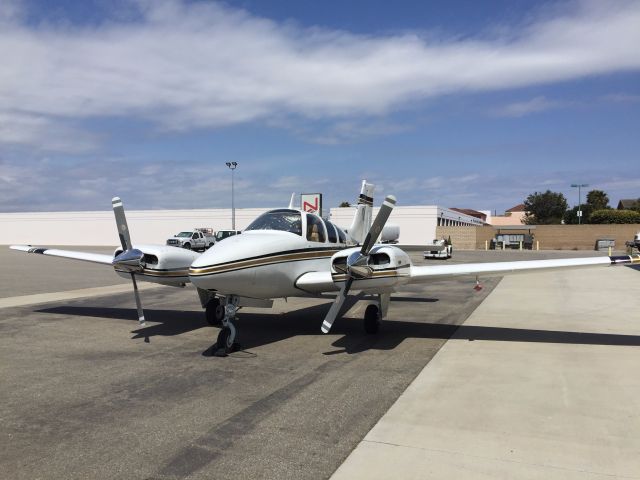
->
321;195;396;333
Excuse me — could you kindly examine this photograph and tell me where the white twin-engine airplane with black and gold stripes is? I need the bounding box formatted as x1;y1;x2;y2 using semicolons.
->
10;181;640;355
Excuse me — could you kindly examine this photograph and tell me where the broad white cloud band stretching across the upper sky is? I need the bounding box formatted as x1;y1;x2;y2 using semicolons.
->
0;0;640;150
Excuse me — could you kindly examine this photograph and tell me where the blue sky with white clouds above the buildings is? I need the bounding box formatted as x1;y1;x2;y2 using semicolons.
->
0;0;640;213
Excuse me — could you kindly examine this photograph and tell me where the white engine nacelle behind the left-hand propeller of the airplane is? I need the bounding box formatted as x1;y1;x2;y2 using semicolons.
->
113;245;200;286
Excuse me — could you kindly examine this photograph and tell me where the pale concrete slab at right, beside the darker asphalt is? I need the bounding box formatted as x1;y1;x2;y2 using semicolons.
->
332;267;640;480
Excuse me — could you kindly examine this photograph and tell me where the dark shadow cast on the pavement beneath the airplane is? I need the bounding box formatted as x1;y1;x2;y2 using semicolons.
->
37;299;640;355
